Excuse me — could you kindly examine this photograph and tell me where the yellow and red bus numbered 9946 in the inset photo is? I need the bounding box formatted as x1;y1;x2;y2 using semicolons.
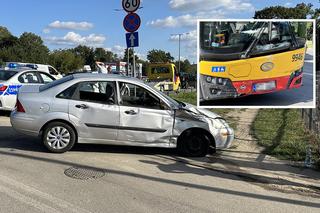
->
199;21;306;101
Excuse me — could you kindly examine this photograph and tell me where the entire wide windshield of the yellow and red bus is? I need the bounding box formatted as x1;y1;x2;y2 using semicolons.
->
200;21;302;60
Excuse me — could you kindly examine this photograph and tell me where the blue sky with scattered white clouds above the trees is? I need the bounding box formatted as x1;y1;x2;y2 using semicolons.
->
0;0;320;63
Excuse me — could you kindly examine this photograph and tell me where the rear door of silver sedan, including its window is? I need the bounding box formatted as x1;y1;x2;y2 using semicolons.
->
69;81;119;143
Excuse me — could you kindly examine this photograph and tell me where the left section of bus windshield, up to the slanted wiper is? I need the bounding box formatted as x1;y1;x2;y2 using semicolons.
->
200;22;265;54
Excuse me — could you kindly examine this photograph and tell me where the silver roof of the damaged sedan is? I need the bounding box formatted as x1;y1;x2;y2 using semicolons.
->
72;73;142;83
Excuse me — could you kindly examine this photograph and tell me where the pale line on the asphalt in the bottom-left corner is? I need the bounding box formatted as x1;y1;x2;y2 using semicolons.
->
0;175;90;213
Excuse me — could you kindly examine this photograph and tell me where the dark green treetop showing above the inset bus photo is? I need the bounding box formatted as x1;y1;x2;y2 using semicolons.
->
254;3;314;19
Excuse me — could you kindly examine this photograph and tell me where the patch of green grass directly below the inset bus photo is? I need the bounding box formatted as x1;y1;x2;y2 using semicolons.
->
252;109;320;166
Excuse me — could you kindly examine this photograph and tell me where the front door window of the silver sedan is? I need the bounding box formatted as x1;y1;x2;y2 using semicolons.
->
119;82;164;109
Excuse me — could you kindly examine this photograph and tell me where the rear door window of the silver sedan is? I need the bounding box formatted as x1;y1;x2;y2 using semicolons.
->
74;81;116;104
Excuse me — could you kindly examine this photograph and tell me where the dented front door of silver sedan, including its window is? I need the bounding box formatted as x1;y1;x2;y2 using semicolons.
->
118;82;174;145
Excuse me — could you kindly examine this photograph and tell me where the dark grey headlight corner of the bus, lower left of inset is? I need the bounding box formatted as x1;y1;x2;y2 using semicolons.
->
200;75;238;101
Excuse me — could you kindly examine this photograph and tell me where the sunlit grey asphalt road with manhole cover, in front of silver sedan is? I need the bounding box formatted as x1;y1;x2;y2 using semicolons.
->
0;116;320;213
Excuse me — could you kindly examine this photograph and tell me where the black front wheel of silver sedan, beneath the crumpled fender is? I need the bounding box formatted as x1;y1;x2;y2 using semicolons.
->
178;131;209;157
